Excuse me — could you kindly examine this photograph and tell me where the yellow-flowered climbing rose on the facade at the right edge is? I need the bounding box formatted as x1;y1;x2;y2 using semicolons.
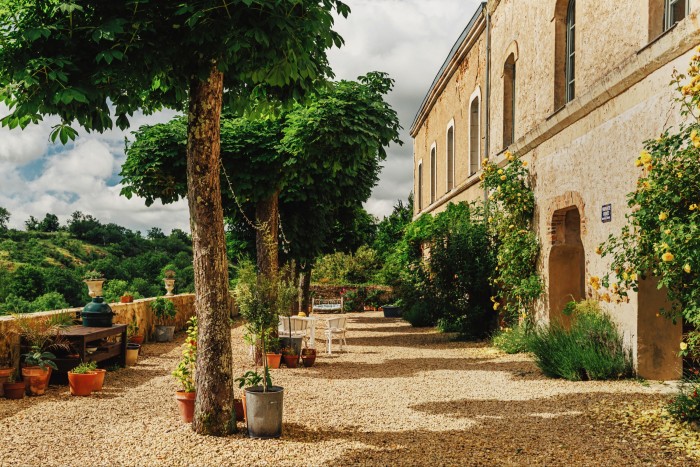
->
598;48;700;356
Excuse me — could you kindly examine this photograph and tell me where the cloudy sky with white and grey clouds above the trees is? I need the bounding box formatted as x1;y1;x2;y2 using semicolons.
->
0;0;479;232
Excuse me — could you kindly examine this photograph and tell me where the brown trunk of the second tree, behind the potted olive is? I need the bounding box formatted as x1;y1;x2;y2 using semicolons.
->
255;190;280;277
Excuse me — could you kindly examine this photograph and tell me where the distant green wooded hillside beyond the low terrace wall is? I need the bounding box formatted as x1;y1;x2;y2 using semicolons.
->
0;212;194;314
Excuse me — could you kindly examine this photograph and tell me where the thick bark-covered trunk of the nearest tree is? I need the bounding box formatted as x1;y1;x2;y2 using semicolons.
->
187;66;236;436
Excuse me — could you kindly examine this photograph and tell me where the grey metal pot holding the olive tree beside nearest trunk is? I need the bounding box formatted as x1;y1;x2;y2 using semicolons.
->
245;386;284;438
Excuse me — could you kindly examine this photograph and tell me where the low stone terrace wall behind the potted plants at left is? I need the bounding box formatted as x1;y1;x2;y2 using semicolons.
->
0;294;195;368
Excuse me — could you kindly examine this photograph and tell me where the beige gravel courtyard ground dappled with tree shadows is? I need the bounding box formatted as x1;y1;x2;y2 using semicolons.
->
0;313;698;466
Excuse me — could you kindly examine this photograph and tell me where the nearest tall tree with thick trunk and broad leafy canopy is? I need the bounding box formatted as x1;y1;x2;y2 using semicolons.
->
0;0;349;435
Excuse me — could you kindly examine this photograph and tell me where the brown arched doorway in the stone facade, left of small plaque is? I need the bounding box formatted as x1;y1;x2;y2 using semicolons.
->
549;206;586;327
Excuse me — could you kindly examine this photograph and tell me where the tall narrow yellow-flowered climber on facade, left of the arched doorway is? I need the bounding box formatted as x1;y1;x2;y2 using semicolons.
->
481;152;543;323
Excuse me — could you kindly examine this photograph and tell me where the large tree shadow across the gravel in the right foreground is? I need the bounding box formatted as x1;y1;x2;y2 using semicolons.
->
284;393;697;466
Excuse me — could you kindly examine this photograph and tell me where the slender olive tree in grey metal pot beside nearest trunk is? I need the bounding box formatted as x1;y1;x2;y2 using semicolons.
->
236;267;294;438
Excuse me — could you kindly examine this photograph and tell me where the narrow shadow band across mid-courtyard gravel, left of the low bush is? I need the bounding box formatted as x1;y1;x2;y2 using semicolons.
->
299;358;548;381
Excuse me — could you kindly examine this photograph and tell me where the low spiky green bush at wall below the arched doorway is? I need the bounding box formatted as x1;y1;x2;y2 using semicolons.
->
528;300;633;381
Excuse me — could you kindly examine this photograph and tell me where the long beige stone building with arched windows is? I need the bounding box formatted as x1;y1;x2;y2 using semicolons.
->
411;0;700;380
